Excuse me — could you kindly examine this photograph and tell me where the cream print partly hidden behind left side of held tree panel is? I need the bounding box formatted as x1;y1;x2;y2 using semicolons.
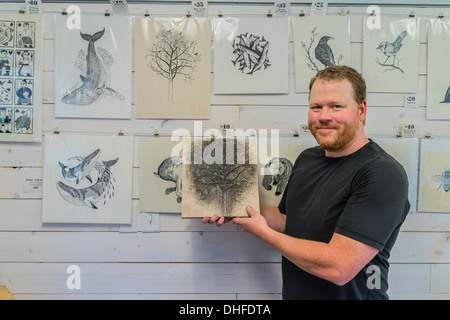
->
139;137;182;213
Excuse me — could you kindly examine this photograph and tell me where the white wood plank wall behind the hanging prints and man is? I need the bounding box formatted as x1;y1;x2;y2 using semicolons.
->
0;1;450;299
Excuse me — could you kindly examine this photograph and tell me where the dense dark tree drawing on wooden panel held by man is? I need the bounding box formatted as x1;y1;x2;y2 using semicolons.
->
183;139;257;217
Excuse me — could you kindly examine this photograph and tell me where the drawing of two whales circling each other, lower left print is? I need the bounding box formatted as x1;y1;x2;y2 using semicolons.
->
56;149;119;209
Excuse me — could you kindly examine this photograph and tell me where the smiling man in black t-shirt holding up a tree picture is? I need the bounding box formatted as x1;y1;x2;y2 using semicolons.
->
202;66;409;299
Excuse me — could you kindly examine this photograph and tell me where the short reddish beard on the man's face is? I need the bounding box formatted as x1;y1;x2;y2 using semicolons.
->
308;117;359;151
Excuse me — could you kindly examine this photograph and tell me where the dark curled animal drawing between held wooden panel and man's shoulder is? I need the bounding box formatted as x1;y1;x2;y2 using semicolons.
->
262;158;293;196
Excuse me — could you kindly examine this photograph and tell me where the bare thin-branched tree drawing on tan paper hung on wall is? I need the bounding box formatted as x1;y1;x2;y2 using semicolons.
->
145;30;201;103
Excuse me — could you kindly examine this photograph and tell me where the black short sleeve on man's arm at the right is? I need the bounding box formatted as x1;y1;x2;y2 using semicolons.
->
335;159;409;250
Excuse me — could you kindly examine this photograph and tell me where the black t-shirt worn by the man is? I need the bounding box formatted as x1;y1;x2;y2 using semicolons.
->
278;141;409;299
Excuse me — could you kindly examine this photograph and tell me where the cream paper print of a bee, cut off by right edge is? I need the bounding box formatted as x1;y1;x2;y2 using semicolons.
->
418;139;450;212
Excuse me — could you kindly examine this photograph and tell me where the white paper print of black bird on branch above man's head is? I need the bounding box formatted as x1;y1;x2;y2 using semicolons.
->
292;16;351;92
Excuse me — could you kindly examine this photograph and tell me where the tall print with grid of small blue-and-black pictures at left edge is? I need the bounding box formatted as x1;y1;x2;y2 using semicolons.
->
0;14;43;142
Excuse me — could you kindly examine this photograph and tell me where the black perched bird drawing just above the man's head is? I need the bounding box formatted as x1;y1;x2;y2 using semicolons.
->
301;27;344;71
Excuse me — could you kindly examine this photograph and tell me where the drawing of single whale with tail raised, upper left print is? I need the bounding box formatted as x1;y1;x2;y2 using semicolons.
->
62;28;125;105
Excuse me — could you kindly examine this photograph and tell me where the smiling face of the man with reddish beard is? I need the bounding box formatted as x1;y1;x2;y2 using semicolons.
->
308;79;366;153
